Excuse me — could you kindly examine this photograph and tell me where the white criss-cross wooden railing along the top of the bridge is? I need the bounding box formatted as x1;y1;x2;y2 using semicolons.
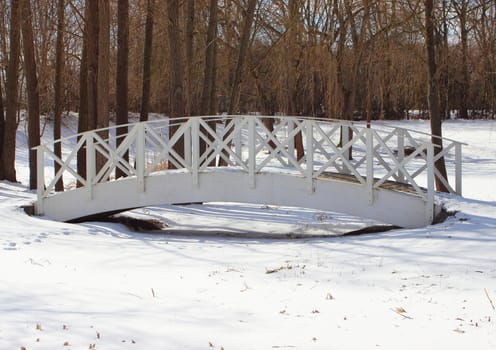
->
37;116;462;213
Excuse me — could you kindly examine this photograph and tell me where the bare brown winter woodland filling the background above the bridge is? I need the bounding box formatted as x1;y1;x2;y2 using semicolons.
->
0;0;496;188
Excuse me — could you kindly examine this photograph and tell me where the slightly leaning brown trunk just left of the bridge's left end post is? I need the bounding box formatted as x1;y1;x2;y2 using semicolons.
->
21;0;40;189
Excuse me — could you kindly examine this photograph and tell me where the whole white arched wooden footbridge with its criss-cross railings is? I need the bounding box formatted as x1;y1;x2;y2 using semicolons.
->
35;116;462;227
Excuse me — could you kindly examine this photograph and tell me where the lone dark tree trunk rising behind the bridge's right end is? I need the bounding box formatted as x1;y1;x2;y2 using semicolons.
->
424;0;448;192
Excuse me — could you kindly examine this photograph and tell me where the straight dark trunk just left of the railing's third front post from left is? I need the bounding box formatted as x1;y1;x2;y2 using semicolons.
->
115;0;129;178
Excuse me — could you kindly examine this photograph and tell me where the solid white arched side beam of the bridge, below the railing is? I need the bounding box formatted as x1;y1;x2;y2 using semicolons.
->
37;170;441;228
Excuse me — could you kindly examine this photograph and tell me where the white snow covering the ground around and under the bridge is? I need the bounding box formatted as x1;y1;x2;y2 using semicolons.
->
0;117;496;350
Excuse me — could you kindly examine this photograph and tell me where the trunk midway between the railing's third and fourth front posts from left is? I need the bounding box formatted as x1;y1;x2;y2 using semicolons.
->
167;0;184;168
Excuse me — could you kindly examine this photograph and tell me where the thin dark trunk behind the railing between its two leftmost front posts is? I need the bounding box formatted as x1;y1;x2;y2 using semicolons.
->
53;0;65;191
